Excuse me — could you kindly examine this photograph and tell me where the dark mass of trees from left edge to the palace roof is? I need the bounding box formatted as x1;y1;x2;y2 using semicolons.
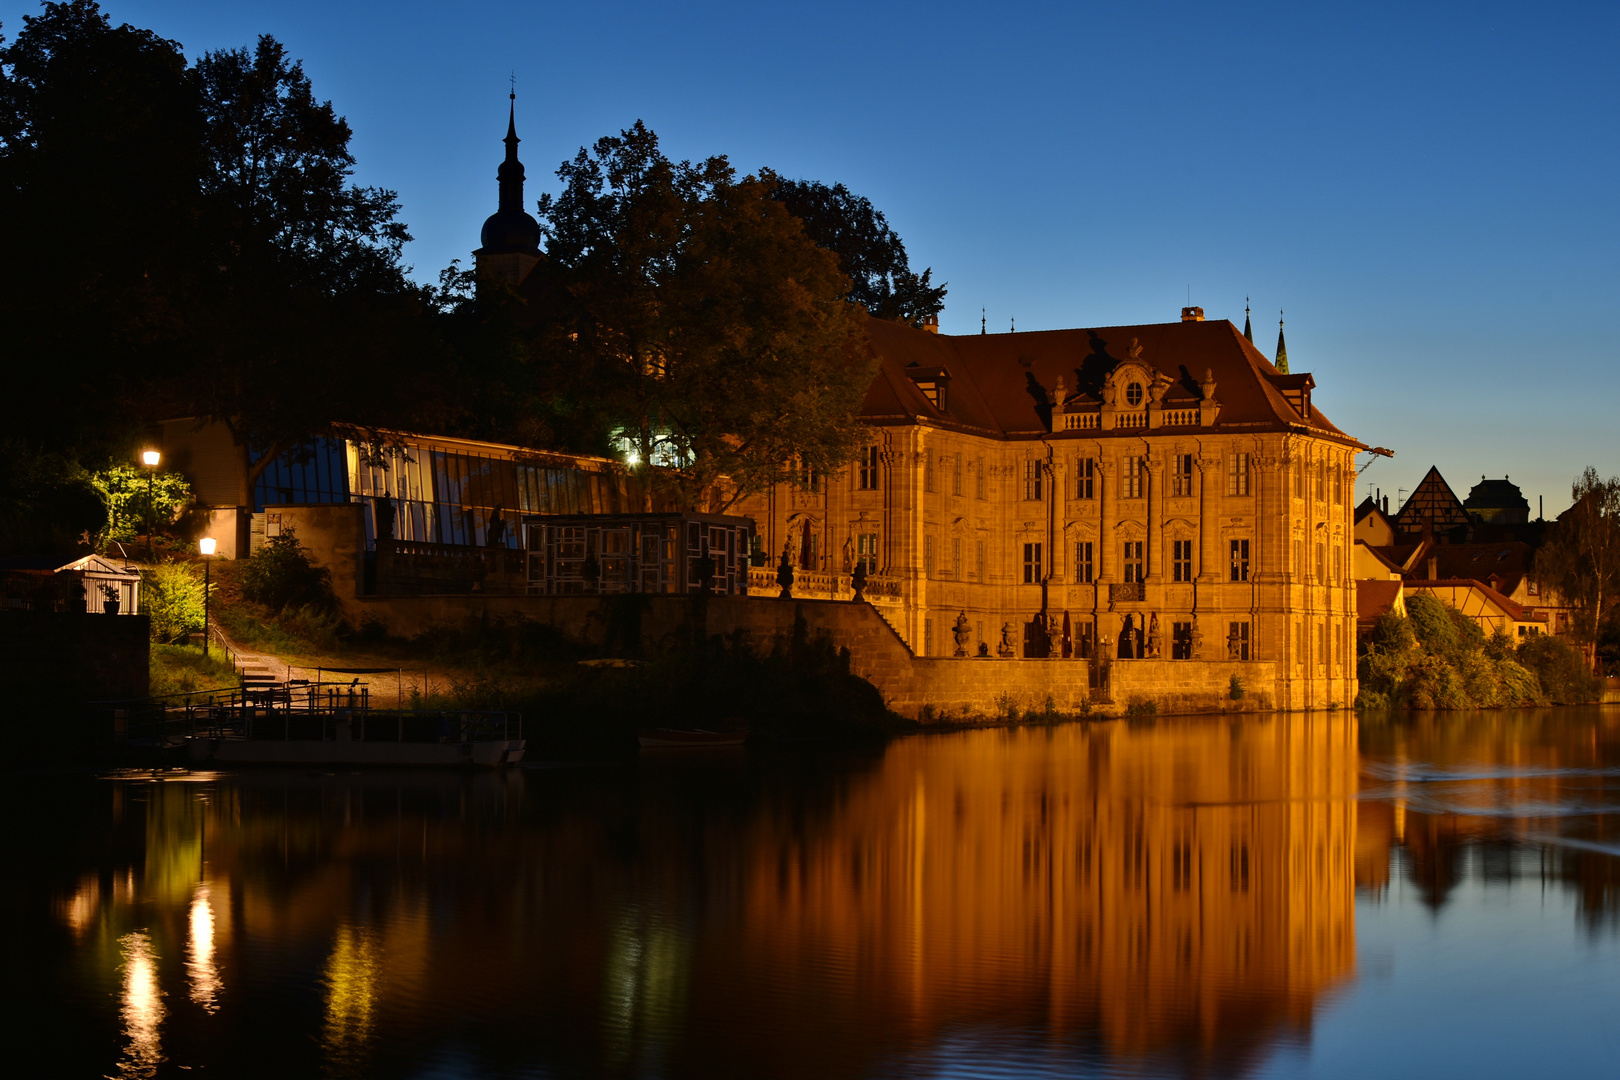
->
0;0;944;552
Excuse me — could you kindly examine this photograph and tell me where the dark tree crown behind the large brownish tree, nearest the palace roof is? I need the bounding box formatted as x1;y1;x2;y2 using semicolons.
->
761;168;944;325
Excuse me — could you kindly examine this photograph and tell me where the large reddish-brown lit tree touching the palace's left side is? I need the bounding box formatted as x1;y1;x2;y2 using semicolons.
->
538;121;875;508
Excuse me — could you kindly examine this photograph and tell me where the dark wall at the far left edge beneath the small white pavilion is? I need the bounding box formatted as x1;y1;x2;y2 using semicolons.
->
0;610;152;719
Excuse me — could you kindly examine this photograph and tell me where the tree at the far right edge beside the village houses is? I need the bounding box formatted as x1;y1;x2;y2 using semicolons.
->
1536;465;1620;662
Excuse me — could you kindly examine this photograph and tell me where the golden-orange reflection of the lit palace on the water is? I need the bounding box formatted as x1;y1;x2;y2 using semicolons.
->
737;716;1356;1056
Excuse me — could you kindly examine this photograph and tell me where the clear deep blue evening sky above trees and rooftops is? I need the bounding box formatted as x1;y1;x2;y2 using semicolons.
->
0;0;1620;513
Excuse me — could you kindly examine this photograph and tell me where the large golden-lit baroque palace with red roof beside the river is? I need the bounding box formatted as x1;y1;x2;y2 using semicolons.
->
734;308;1366;708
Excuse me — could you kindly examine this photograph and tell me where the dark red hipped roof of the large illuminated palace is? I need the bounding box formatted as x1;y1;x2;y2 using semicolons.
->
860;319;1359;445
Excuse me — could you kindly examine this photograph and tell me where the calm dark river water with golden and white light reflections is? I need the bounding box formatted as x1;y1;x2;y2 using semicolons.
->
9;709;1620;1077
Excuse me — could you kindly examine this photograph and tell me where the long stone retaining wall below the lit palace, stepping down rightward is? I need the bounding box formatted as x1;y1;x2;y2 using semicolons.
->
352;594;1275;717
